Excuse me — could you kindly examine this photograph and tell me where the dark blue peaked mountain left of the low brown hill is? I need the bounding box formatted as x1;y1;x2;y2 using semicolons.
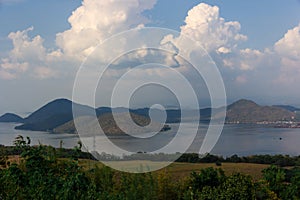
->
16;99;95;131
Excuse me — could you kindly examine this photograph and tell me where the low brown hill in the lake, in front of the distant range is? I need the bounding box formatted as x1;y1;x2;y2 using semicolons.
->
53;113;170;135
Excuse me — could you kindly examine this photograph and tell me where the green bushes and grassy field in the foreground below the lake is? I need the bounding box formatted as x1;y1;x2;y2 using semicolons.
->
0;138;300;200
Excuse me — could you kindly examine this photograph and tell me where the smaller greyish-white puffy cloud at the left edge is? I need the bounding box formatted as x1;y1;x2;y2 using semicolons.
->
0;27;57;79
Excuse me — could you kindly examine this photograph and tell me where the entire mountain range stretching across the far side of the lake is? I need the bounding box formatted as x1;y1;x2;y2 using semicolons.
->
0;99;300;132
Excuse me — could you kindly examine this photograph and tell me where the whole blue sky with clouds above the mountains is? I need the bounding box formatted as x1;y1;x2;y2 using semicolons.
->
0;0;300;114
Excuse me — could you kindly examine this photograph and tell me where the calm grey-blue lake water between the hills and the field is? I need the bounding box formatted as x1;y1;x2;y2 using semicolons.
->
0;123;300;156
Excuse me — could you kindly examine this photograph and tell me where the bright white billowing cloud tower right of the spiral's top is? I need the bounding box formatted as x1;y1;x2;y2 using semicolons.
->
181;3;247;53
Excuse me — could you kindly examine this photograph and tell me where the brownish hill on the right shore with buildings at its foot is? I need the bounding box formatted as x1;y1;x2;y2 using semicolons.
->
226;99;296;123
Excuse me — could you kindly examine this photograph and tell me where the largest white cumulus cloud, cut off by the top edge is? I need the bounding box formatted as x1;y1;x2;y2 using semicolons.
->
56;0;156;60
